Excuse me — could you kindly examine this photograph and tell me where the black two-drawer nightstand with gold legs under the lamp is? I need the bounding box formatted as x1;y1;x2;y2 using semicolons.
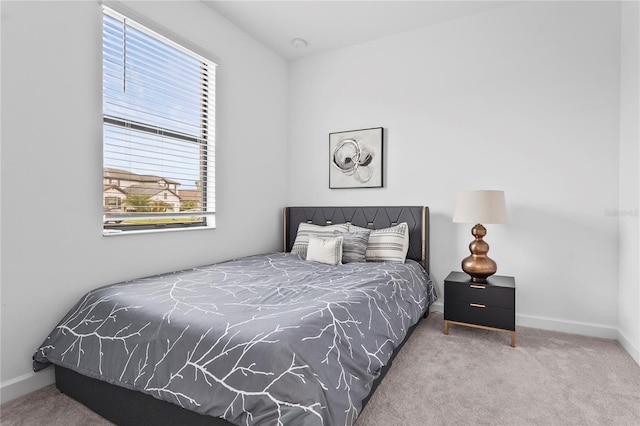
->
444;272;516;347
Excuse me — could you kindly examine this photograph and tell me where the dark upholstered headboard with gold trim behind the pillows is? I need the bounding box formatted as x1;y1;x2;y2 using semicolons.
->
284;206;429;272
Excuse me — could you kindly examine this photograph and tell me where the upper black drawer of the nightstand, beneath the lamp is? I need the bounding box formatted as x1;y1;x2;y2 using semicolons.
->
444;281;516;309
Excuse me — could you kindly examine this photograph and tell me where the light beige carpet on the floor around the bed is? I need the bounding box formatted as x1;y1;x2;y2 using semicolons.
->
0;313;640;426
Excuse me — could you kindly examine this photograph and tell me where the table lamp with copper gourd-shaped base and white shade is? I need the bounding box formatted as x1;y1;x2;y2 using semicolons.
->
453;190;507;283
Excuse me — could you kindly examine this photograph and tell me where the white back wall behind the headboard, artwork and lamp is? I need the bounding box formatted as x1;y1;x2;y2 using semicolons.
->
288;2;624;338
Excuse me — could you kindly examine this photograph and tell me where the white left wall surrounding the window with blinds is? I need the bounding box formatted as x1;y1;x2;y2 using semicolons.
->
0;1;288;401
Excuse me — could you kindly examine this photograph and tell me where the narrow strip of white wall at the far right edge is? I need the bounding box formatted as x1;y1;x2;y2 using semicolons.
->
618;2;640;364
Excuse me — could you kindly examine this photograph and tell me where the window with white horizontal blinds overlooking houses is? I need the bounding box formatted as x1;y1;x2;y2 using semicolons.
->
102;7;216;234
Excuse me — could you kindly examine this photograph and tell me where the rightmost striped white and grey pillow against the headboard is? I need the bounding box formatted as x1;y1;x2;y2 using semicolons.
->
349;222;409;263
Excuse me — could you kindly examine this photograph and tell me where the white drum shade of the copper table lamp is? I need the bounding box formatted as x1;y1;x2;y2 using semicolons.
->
453;190;507;223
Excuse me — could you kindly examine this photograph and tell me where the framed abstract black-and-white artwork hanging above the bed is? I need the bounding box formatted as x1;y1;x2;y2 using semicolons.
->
329;127;384;189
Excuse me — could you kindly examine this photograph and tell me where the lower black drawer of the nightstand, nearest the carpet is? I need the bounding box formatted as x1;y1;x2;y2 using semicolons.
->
444;294;516;330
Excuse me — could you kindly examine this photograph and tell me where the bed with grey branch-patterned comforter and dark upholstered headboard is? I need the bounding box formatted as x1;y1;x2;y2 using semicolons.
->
34;206;436;426
